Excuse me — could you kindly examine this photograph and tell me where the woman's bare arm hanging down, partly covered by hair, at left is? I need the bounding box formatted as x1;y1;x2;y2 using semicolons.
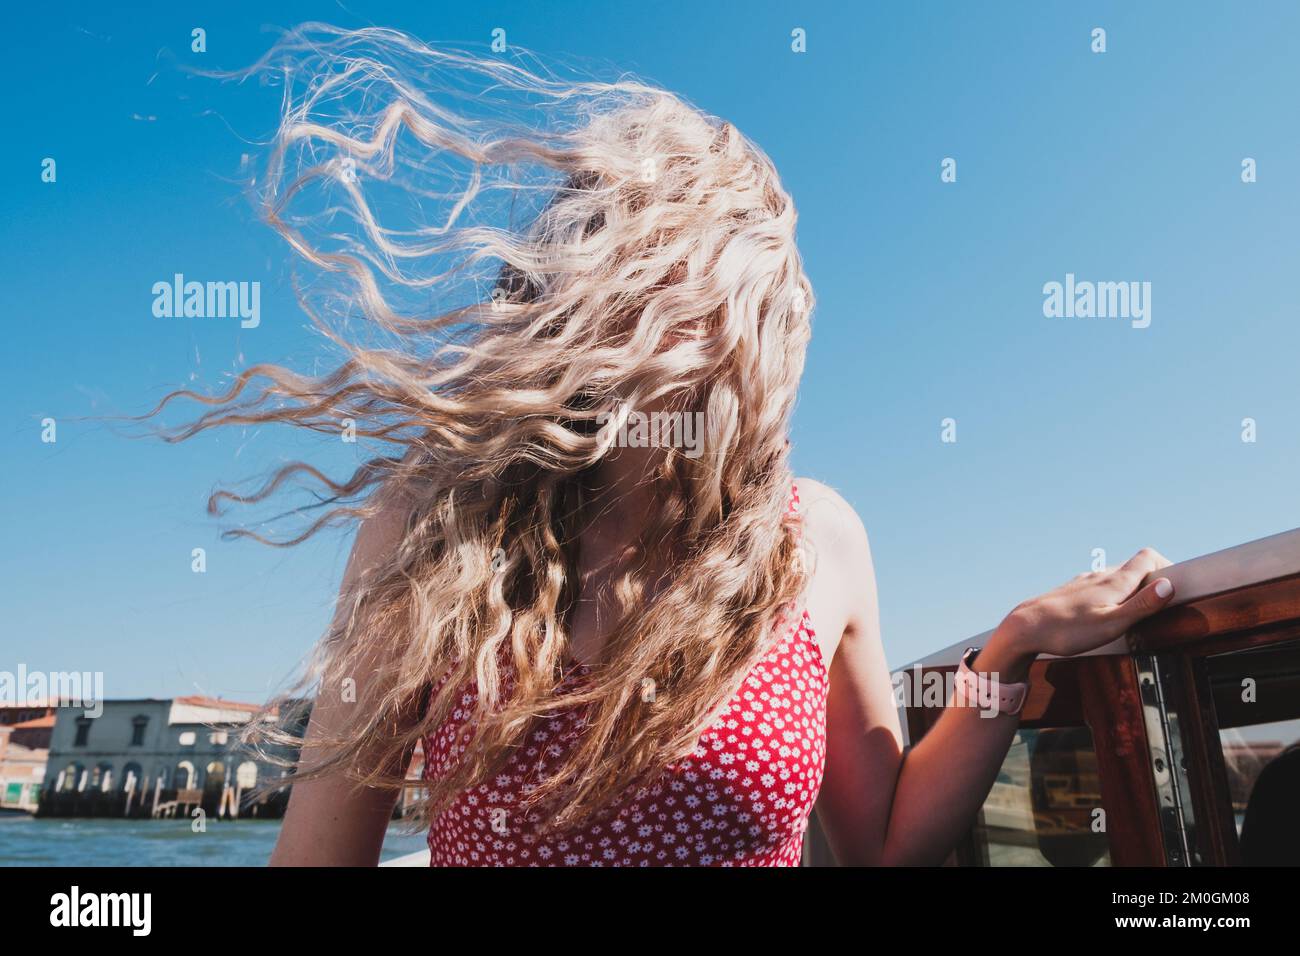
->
270;509;416;866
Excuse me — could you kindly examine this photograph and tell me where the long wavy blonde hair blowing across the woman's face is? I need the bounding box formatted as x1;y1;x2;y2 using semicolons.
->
160;25;813;829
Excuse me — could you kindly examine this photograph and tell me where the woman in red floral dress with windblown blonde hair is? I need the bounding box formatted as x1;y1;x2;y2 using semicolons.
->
165;27;1173;865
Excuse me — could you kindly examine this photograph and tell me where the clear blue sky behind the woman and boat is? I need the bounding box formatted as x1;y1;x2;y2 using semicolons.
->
0;1;1300;700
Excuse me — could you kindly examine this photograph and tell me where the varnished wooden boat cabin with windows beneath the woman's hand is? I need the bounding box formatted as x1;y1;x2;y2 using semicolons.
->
805;529;1300;866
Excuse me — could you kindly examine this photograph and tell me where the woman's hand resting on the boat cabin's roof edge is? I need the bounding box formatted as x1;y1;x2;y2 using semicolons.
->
997;548;1174;659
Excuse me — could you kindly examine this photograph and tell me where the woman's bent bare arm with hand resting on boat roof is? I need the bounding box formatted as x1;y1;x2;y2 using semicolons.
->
800;480;1173;865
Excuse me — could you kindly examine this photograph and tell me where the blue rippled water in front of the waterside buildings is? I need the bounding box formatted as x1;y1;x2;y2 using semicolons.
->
0;814;424;866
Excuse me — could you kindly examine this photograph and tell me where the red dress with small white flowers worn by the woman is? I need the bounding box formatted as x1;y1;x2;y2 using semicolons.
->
424;490;828;866
